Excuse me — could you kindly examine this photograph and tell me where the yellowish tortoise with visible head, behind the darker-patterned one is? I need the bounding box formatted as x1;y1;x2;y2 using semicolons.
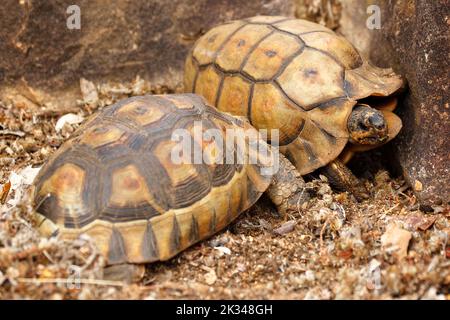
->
184;16;404;200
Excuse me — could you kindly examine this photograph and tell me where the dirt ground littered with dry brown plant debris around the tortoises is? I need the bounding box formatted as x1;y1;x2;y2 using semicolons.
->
0;78;450;299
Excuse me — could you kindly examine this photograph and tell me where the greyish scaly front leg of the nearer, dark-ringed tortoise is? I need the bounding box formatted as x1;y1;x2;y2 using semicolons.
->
266;153;310;216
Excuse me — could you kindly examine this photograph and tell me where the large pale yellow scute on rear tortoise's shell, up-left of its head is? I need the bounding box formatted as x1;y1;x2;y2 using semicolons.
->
277;48;345;110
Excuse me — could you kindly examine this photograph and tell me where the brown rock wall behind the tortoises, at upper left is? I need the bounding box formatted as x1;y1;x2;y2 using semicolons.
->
0;0;294;109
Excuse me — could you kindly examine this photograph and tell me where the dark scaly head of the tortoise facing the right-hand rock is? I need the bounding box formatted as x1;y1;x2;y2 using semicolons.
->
347;104;393;146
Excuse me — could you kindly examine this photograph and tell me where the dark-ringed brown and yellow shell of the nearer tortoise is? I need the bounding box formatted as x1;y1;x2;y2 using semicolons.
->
34;94;272;265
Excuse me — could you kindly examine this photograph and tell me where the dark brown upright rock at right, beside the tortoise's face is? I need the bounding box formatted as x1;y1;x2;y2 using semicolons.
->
339;0;450;206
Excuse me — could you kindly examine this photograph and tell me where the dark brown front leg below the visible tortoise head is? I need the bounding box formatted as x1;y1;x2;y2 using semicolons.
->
320;159;369;201
